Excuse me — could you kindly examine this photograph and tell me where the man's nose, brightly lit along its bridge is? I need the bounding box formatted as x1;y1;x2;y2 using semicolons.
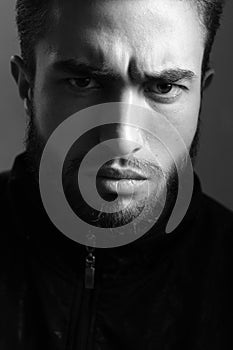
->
99;92;143;157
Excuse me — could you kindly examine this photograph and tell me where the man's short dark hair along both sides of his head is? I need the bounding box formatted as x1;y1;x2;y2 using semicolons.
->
16;0;225;75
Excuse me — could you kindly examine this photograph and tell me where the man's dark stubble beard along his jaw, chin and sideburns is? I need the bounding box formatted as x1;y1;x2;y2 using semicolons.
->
25;99;200;228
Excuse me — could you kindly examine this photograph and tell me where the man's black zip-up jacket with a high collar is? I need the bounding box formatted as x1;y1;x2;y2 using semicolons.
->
0;154;233;350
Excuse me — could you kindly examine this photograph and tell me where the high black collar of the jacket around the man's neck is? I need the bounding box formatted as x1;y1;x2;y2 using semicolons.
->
7;153;202;276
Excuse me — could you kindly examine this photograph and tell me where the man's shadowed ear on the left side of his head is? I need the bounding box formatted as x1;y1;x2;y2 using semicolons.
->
10;56;32;101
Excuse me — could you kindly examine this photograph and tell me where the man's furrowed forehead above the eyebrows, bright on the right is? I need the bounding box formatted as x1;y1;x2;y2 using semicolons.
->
36;0;204;75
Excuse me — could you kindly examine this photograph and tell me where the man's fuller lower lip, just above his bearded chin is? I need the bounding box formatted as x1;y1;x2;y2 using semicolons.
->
97;177;147;195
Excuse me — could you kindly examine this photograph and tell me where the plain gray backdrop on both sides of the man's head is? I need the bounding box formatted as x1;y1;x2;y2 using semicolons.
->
0;0;233;210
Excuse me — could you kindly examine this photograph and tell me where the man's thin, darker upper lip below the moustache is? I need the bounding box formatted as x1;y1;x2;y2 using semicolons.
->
98;168;147;180
